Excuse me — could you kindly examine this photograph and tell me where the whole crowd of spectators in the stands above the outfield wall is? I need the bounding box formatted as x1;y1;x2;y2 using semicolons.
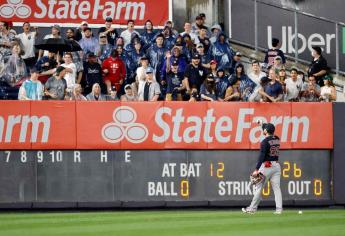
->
0;14;336;102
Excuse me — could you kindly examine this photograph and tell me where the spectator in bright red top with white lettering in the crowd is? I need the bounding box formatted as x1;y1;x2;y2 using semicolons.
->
102;50;126;92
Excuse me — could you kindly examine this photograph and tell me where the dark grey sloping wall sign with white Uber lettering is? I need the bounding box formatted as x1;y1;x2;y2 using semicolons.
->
230;0;345;71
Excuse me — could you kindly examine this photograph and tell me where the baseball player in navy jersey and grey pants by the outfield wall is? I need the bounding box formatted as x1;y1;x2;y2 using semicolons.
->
242;123;283;214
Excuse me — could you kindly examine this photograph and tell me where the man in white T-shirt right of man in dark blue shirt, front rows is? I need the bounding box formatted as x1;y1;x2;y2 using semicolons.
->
284;68;303;102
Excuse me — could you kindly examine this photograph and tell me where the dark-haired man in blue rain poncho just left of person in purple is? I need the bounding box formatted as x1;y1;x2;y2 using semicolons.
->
146;34;166;83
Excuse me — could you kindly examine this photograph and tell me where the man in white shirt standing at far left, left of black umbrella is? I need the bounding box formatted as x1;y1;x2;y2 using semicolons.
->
16;22;37;70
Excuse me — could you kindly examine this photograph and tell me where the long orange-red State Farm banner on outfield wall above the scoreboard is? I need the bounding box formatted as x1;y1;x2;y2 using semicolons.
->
0;101;333;150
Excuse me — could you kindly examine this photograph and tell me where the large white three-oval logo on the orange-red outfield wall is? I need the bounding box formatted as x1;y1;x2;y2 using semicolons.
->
102;106;149;143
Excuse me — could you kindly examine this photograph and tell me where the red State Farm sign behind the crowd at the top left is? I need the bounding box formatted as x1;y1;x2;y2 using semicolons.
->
0;0;171;26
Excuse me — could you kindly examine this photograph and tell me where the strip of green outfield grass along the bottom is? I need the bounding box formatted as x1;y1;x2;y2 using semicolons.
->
0;210;345;236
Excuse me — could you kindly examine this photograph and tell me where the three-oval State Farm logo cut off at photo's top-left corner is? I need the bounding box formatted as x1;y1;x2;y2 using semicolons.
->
0;0;31;18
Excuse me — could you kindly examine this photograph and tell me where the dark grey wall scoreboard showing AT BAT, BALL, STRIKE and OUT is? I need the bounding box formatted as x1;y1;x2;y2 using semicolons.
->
0;150;332;203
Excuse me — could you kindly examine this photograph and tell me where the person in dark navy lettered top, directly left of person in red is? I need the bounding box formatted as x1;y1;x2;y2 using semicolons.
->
83;52;103;95
